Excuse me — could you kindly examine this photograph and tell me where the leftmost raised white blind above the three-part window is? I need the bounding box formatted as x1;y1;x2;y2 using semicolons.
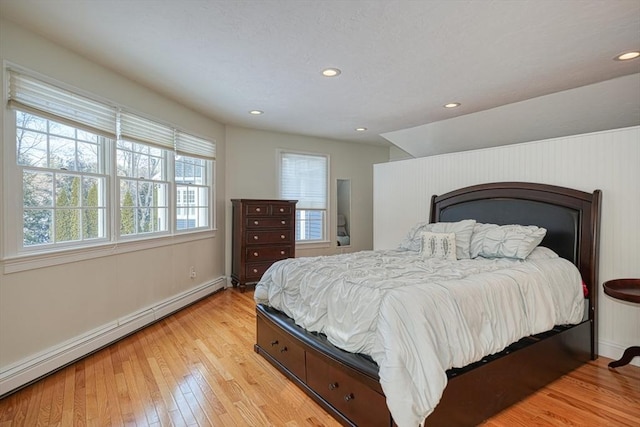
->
8;69;116;138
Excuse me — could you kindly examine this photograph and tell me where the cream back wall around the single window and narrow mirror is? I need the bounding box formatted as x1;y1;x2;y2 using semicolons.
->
226;126;389;262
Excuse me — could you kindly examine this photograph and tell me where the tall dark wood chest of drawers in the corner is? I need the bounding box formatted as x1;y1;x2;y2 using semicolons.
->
231;199;297;291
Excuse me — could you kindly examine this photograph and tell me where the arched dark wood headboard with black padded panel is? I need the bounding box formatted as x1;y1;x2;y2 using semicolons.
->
430;182;602;354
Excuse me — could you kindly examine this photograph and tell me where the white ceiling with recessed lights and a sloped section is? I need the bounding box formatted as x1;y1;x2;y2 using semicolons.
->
0;0;640;157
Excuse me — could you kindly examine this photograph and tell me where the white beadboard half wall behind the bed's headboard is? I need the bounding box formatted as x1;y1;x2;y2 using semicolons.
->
374;127;640;364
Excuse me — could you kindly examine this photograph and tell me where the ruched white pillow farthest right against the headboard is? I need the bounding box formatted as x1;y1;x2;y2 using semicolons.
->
480;225;547;259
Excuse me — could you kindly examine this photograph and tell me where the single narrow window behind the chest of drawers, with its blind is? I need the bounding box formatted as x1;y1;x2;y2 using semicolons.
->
280;151;329;242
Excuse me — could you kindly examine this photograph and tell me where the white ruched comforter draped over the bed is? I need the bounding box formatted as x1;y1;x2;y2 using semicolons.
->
255;248;583;427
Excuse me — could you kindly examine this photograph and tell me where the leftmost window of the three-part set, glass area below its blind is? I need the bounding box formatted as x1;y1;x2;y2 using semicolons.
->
16;111;107;247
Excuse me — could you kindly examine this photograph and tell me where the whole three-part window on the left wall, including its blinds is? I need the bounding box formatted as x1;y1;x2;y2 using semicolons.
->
3;69;215;256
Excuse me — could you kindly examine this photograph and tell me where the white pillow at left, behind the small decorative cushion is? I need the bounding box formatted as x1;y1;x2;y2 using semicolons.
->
400;219;476;259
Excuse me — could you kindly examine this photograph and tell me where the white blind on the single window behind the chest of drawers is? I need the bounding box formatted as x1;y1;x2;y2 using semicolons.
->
280;153;328;210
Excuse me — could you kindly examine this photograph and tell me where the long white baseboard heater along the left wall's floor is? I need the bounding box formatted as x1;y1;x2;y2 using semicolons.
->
0;277;226;396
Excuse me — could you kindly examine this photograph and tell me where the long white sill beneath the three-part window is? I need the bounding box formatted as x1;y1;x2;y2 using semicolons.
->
3;230;216;274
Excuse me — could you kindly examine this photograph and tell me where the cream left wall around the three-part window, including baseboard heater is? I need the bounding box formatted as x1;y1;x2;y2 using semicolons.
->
0;20;226;395
